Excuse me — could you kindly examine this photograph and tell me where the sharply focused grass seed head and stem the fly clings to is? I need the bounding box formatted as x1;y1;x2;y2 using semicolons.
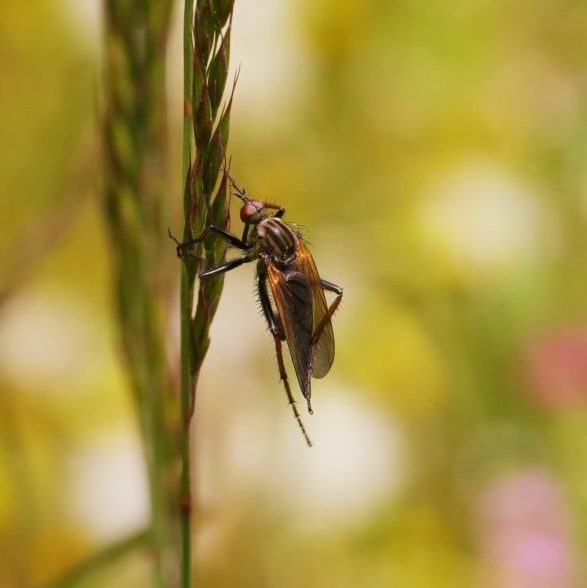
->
180;0;233;588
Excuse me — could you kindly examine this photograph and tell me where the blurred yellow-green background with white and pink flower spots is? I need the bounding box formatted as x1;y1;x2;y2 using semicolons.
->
0;0;587;588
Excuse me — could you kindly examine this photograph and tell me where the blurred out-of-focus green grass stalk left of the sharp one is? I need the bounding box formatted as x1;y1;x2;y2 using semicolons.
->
103;0;179;588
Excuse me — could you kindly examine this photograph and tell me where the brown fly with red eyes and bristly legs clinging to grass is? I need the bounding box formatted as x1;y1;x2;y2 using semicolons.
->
170;172;342;446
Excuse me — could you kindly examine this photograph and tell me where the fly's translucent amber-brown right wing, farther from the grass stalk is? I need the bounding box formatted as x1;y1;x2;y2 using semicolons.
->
298;239;334;378
